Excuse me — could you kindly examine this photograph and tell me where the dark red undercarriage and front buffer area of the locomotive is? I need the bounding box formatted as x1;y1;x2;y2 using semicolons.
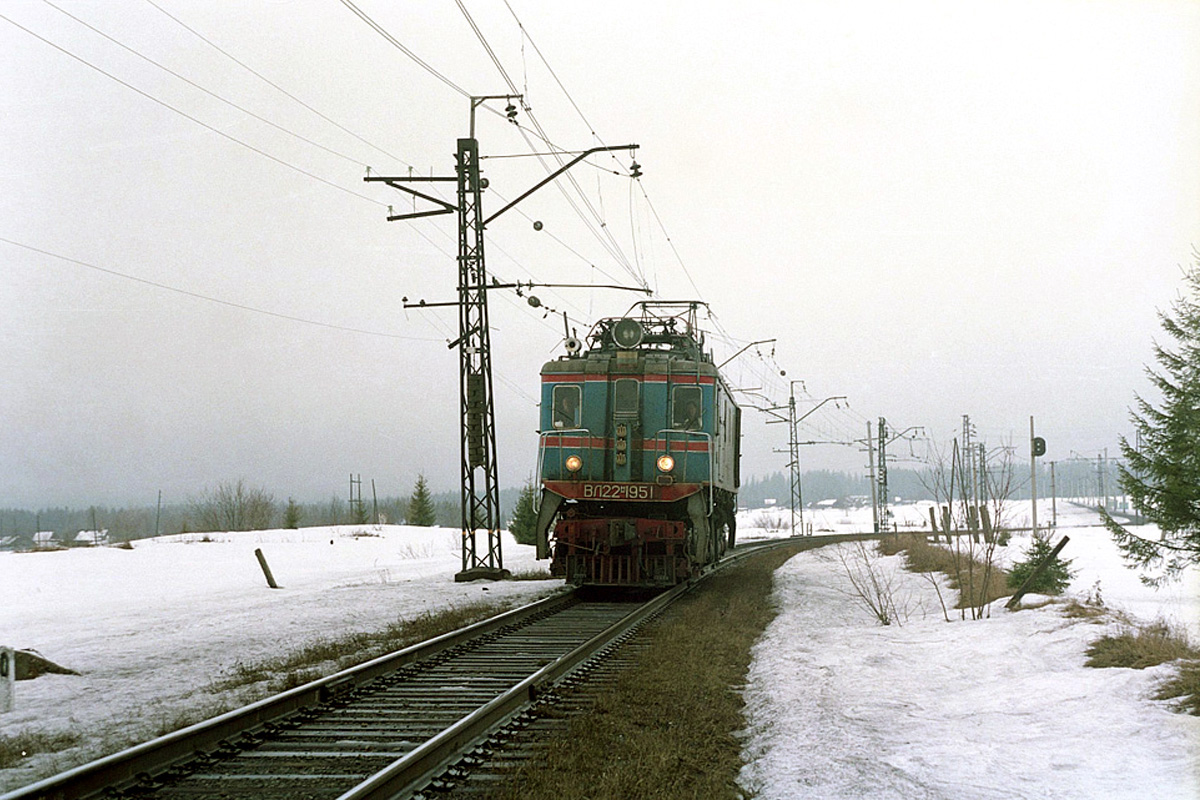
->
550;491;736;587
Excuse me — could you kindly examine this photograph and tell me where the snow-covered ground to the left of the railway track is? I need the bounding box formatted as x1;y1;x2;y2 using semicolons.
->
0;525;563;790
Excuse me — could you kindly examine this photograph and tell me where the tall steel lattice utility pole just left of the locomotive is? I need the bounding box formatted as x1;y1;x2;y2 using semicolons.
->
364;95;641;582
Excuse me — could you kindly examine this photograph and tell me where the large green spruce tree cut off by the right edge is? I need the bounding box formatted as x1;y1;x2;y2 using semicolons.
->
1102;252;1200;585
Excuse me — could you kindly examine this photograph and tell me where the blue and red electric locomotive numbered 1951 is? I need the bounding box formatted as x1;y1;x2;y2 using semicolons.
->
536;302;742;587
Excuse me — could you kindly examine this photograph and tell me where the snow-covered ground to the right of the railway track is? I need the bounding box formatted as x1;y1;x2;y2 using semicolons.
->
739;504;1200;800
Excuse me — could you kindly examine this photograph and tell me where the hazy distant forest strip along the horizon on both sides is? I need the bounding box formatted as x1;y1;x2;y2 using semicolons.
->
0;459;1120;541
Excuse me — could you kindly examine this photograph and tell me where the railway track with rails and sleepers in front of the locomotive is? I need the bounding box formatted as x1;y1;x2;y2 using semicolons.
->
0;545;806;800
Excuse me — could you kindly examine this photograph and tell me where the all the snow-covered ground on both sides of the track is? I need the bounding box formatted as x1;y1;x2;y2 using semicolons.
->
0;504;1200;800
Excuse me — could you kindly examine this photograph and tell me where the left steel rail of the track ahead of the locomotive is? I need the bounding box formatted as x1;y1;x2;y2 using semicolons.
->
0;593;572;800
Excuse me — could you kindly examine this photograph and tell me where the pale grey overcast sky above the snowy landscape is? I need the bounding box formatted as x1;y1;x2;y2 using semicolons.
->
0;0;1200;507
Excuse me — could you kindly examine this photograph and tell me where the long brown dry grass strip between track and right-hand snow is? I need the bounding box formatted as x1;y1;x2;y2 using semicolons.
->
480;548;796;800
